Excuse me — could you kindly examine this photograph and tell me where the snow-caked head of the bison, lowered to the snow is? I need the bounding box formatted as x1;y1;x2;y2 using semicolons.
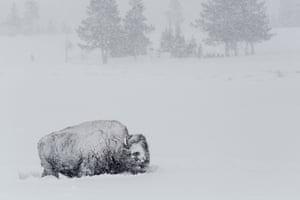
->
125;134;150;174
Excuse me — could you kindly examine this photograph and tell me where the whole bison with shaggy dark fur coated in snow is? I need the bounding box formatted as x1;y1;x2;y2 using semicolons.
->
38;121;150;177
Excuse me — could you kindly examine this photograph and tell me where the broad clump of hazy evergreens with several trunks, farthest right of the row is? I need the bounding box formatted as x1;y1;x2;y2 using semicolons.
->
195;0;271;56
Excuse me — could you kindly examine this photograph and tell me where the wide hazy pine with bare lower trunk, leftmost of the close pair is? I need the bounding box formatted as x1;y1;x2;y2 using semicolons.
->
77;0;121;64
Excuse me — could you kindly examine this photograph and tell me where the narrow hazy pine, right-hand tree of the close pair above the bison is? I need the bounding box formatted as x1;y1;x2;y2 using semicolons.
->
124;0;154;58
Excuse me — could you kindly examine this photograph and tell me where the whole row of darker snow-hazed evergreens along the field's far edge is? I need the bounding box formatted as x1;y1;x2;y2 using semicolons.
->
77;0;272;63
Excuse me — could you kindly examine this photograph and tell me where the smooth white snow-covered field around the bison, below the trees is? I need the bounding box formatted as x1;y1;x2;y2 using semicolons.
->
0;29;300;200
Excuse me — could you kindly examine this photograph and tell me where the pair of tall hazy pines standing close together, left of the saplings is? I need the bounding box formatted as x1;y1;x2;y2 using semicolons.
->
77;0;154;64
